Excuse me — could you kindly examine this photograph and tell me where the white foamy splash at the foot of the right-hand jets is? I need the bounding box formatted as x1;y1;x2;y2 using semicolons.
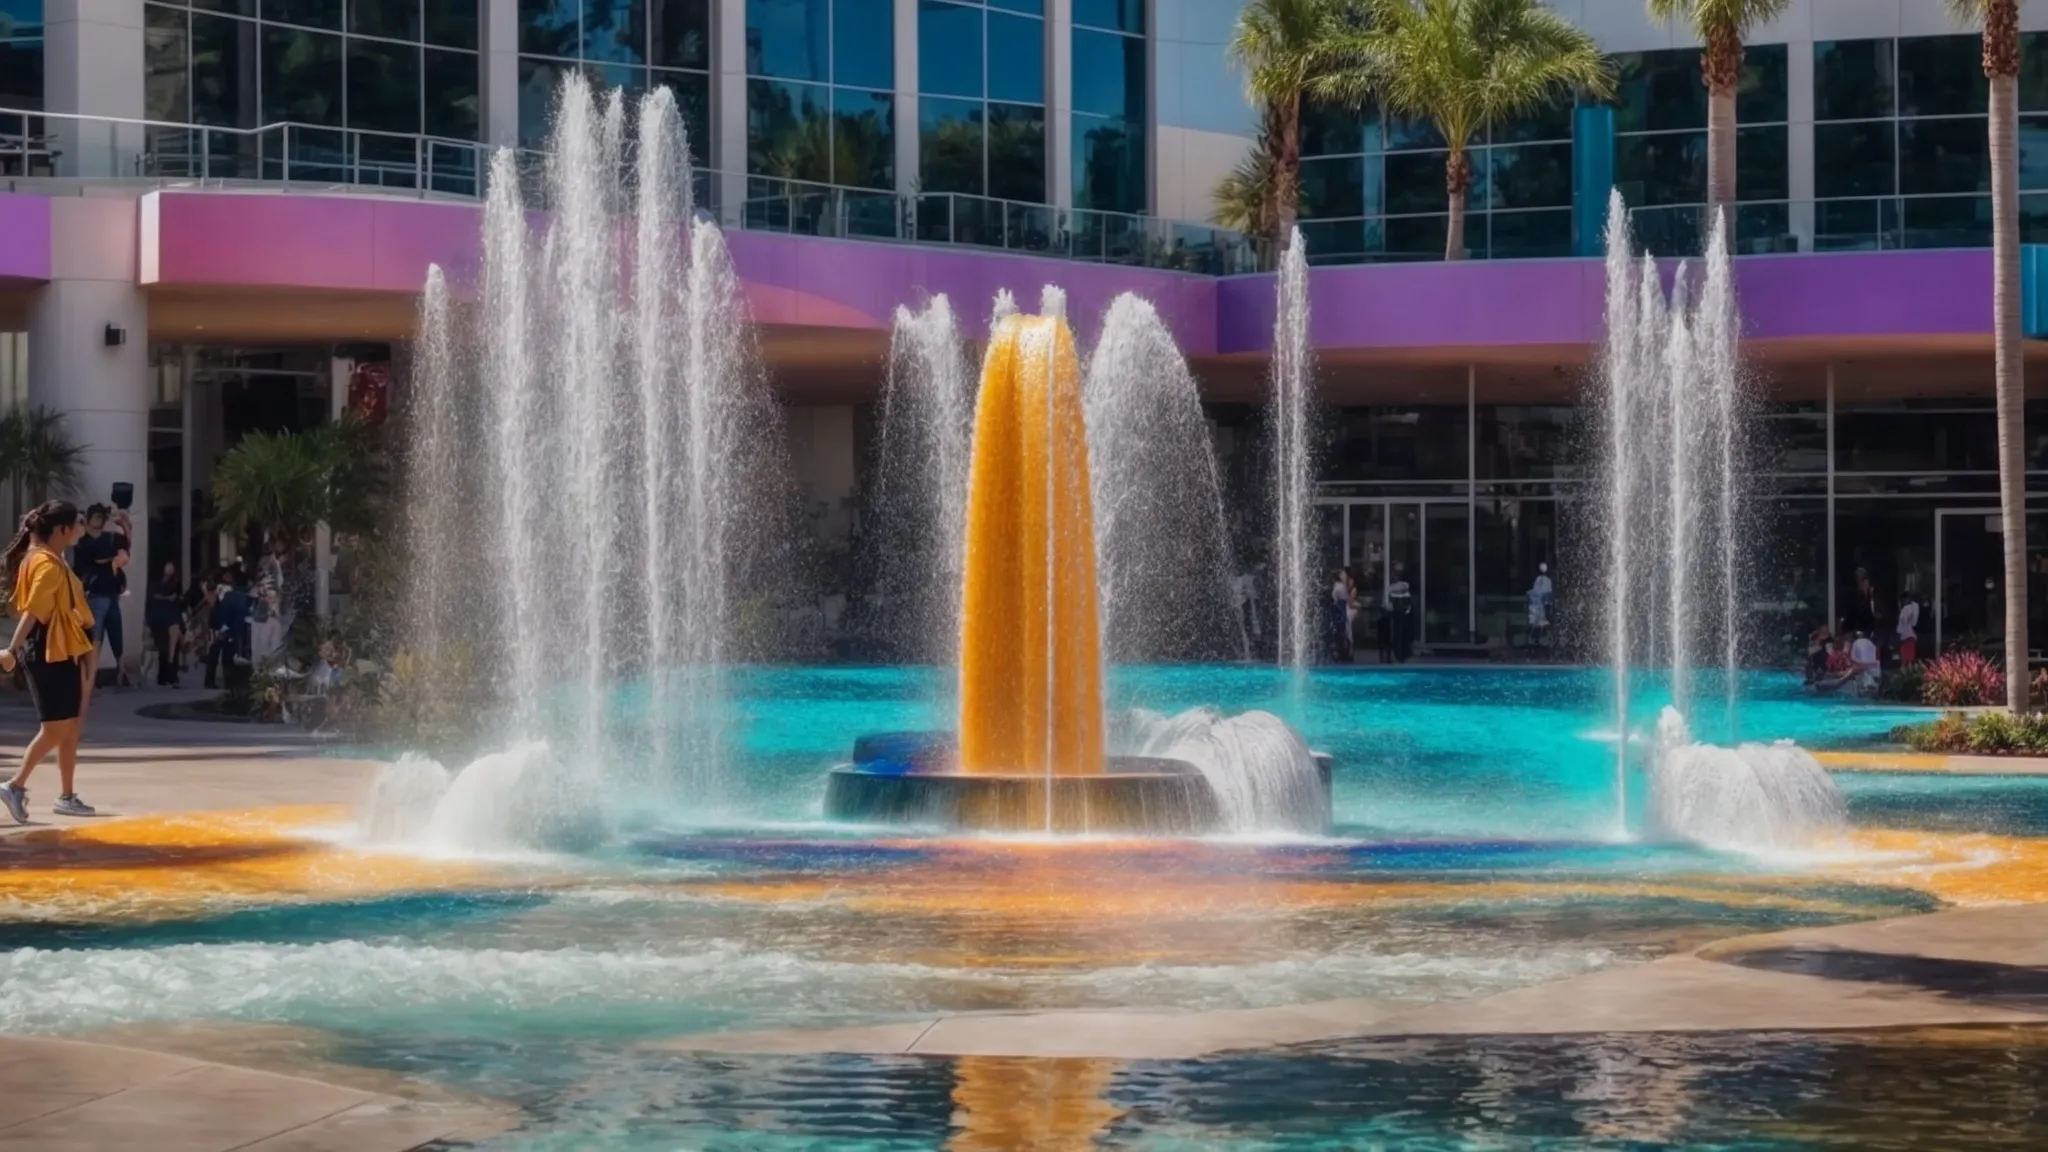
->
1651;707;1849;849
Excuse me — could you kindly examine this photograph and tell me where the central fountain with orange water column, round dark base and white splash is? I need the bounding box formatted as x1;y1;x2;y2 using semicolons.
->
825;309;1329;834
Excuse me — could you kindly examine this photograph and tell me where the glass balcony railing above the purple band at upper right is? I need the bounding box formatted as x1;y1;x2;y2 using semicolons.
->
1628;193;2023;256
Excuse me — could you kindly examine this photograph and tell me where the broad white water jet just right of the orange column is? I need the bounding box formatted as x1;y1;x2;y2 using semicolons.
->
1083;293;1245;662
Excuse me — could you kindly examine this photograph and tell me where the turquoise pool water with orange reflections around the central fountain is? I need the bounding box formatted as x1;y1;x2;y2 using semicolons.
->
0;666;1998;1150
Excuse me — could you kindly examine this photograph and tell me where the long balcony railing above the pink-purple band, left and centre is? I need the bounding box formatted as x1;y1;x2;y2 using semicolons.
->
0;109;1266;275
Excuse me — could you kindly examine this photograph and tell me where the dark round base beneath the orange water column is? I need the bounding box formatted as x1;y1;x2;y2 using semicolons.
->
825;732;1329;836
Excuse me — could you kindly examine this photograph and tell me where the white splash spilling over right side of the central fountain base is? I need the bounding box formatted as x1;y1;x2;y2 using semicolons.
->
1112;707;1331;832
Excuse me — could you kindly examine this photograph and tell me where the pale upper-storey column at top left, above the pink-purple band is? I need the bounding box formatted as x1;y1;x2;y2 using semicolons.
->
43;0;145;176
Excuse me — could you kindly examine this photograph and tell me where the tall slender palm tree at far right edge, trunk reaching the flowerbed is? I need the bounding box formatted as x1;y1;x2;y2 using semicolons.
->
1948;0;2028;711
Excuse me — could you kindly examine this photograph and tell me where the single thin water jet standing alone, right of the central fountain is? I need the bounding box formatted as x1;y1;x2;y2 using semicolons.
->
1268;230;1319;672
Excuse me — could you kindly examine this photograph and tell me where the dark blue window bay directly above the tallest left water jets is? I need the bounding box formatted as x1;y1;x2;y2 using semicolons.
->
516;0;711;164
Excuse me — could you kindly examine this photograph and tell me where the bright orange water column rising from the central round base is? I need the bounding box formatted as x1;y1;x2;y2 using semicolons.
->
961;316;1104;775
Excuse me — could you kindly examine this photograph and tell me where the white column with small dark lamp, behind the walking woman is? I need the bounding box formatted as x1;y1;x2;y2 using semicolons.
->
29;197;150;660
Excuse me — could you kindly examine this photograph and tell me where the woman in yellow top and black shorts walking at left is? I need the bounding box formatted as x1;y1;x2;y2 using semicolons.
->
0;500;94;824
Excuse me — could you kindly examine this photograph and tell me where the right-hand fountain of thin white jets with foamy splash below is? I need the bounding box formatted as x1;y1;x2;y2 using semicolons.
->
1599;193;1845;849
